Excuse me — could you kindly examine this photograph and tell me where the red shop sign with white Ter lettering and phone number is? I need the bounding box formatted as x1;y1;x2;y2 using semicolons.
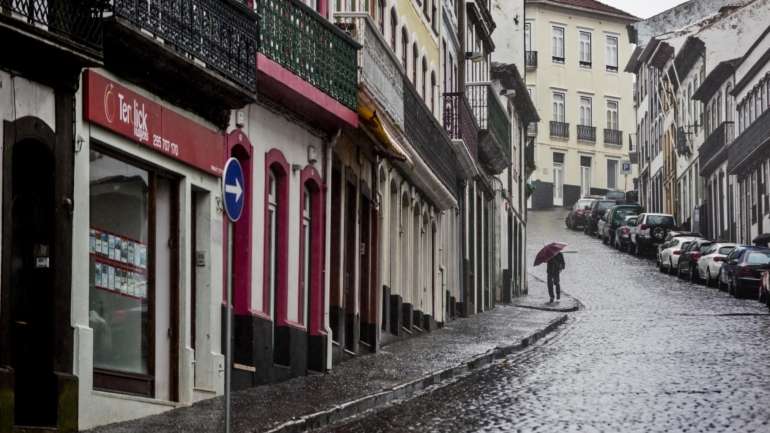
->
83;70;224;176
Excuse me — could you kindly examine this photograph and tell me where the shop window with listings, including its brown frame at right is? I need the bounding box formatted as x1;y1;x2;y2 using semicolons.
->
89;150;178;399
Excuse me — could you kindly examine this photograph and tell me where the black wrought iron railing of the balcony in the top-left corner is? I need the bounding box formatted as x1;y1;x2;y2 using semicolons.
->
0;0;104;51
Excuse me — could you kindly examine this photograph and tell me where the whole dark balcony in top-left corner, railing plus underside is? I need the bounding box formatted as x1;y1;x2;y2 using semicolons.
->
0;0;104;80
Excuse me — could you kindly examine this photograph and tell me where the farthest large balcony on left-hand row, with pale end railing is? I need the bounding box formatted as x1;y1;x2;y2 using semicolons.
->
465;83;511;174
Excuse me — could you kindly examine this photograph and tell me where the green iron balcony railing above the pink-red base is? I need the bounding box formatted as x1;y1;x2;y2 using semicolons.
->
257;0;359;110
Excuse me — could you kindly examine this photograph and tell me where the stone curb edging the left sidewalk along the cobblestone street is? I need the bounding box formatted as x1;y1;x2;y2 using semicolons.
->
265;314;568;433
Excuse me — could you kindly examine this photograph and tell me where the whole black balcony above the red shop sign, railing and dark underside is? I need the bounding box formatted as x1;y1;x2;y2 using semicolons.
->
104;0;257;127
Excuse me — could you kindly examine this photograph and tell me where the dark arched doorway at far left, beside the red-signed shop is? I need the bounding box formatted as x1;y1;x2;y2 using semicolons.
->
3;141;56;426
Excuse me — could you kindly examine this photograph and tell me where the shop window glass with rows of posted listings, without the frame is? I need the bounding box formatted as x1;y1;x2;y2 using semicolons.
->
89;151;152;375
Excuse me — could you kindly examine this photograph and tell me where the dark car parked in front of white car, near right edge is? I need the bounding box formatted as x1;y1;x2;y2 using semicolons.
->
719;246;770;299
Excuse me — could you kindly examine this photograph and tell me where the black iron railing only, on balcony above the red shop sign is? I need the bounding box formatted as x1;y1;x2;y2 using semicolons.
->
112;0;257;92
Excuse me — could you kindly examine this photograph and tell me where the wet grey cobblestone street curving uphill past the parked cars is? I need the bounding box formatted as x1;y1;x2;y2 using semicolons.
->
327;211;770;433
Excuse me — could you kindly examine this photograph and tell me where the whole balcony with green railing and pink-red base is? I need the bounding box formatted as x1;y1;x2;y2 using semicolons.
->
256;0;360;127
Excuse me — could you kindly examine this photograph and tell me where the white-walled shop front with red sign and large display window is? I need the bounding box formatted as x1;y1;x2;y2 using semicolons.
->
72;70;226;428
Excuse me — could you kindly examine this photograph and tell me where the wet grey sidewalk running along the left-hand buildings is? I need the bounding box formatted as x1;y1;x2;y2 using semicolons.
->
89;304;567;433
